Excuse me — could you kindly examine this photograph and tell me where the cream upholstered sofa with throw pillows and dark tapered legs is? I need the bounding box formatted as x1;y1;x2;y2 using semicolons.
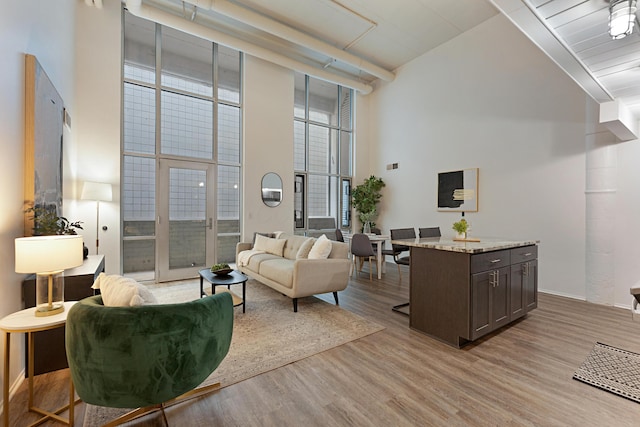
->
236;233;351;312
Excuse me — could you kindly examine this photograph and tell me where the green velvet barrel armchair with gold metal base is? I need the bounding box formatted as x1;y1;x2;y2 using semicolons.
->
66;293;233;425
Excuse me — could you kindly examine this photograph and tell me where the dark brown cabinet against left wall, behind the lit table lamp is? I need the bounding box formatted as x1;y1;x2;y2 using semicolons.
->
22;255;104;375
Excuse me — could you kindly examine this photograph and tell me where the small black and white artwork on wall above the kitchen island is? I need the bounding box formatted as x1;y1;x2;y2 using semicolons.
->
438;168;478;212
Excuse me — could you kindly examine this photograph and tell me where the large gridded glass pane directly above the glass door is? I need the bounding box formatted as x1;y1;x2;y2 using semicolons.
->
161;91;213;159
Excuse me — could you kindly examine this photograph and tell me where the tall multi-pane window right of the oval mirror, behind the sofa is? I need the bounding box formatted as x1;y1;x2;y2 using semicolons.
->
294;73;354;235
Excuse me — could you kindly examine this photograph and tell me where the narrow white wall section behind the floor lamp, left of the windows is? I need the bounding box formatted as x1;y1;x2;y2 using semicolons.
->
70;1;122;274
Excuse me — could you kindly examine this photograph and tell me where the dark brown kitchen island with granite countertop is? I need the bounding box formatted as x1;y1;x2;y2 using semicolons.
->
391;237;539;348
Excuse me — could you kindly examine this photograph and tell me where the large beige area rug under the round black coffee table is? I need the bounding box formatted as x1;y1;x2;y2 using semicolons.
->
84;280;384;427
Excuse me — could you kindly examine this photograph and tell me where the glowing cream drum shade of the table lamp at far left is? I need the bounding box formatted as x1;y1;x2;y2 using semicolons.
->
15;235;83;273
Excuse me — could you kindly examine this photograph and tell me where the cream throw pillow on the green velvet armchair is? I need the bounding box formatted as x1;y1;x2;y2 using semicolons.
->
91;273;158;307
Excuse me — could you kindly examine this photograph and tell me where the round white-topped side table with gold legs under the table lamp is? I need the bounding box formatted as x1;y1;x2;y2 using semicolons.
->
0;301;75;426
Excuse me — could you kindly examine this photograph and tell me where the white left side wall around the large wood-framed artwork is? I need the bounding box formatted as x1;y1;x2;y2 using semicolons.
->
0;0;76;412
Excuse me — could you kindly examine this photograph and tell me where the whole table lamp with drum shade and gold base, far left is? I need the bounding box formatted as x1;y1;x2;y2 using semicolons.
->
15;235;82;317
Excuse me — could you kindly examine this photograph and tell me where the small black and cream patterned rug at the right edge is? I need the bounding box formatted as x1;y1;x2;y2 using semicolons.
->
573;343;640;403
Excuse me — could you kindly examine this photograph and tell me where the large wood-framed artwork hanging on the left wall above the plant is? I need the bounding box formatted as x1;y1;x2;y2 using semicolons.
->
24;55;65;236
